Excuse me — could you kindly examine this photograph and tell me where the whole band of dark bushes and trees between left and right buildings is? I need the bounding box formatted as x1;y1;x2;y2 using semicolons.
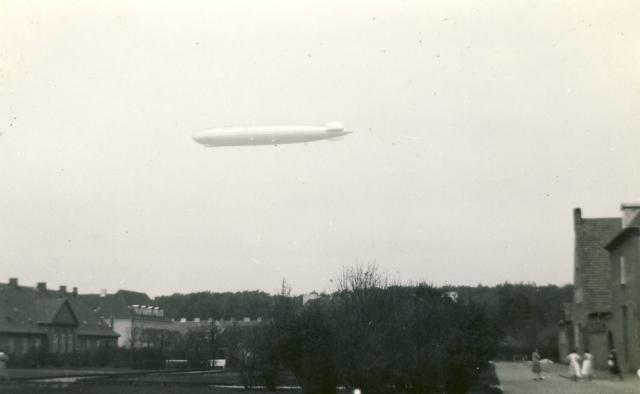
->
148;266;572;394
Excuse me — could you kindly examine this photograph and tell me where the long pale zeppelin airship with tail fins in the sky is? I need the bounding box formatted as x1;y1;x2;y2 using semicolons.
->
193;122;351;147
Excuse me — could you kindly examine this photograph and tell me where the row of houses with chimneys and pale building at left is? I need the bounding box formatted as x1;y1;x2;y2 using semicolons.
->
0;278;262;356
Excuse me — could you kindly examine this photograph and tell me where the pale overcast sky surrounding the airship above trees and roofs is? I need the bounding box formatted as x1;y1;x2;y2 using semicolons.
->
0;0;640;296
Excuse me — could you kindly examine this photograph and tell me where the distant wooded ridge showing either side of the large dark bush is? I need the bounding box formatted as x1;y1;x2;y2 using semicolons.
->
155;280;573;359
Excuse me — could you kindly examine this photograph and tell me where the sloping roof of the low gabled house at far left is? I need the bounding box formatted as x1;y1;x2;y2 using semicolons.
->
0;283;118;337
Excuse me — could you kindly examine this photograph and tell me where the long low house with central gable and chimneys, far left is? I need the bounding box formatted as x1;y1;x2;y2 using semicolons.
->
0;278;118;357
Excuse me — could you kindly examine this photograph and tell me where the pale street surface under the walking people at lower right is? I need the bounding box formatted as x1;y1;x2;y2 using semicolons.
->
495;362;640;394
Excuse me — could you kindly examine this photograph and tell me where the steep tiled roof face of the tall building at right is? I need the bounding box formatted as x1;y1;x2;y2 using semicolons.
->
574;218;622;313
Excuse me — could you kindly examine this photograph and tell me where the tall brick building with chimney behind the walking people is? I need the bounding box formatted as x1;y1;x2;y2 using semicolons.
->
558;203;640;371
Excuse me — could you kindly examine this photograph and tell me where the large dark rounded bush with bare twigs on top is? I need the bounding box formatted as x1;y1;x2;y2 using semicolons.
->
268;268;500;394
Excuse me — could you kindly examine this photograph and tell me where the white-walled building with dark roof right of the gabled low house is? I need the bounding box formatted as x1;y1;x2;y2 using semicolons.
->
80;290;179;348
